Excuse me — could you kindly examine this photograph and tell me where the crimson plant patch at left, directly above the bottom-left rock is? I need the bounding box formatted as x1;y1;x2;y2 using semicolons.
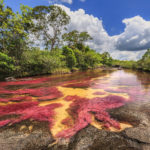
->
0;102;62;127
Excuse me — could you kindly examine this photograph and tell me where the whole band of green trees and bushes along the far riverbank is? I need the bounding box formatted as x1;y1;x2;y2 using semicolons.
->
0;1;150;79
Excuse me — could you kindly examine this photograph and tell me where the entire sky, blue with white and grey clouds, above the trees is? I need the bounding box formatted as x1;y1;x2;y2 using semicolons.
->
5;0;150;60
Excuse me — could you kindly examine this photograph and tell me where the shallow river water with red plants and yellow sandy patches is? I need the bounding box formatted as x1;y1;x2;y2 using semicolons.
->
0;70;150;138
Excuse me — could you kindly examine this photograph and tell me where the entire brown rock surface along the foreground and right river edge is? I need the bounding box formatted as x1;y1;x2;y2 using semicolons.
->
0;101;150;150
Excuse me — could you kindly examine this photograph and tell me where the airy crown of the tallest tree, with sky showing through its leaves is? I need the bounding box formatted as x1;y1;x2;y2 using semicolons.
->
32;6;70;50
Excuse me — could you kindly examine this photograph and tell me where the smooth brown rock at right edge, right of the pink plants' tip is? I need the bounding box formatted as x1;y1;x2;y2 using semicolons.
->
109;101;150;127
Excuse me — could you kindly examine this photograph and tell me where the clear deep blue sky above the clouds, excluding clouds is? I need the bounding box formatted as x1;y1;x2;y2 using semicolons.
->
5;0;150;35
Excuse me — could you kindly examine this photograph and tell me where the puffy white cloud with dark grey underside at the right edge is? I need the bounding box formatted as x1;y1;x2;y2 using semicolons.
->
116;16;150;51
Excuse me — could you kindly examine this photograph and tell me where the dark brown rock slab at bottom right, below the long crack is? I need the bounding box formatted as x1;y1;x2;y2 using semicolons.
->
69;126;150;150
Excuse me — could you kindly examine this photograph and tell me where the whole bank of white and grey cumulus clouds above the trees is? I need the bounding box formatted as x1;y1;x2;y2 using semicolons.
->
59;5;150;60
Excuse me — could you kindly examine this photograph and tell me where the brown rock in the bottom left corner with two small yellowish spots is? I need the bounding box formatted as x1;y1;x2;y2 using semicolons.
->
0;121;55;150
